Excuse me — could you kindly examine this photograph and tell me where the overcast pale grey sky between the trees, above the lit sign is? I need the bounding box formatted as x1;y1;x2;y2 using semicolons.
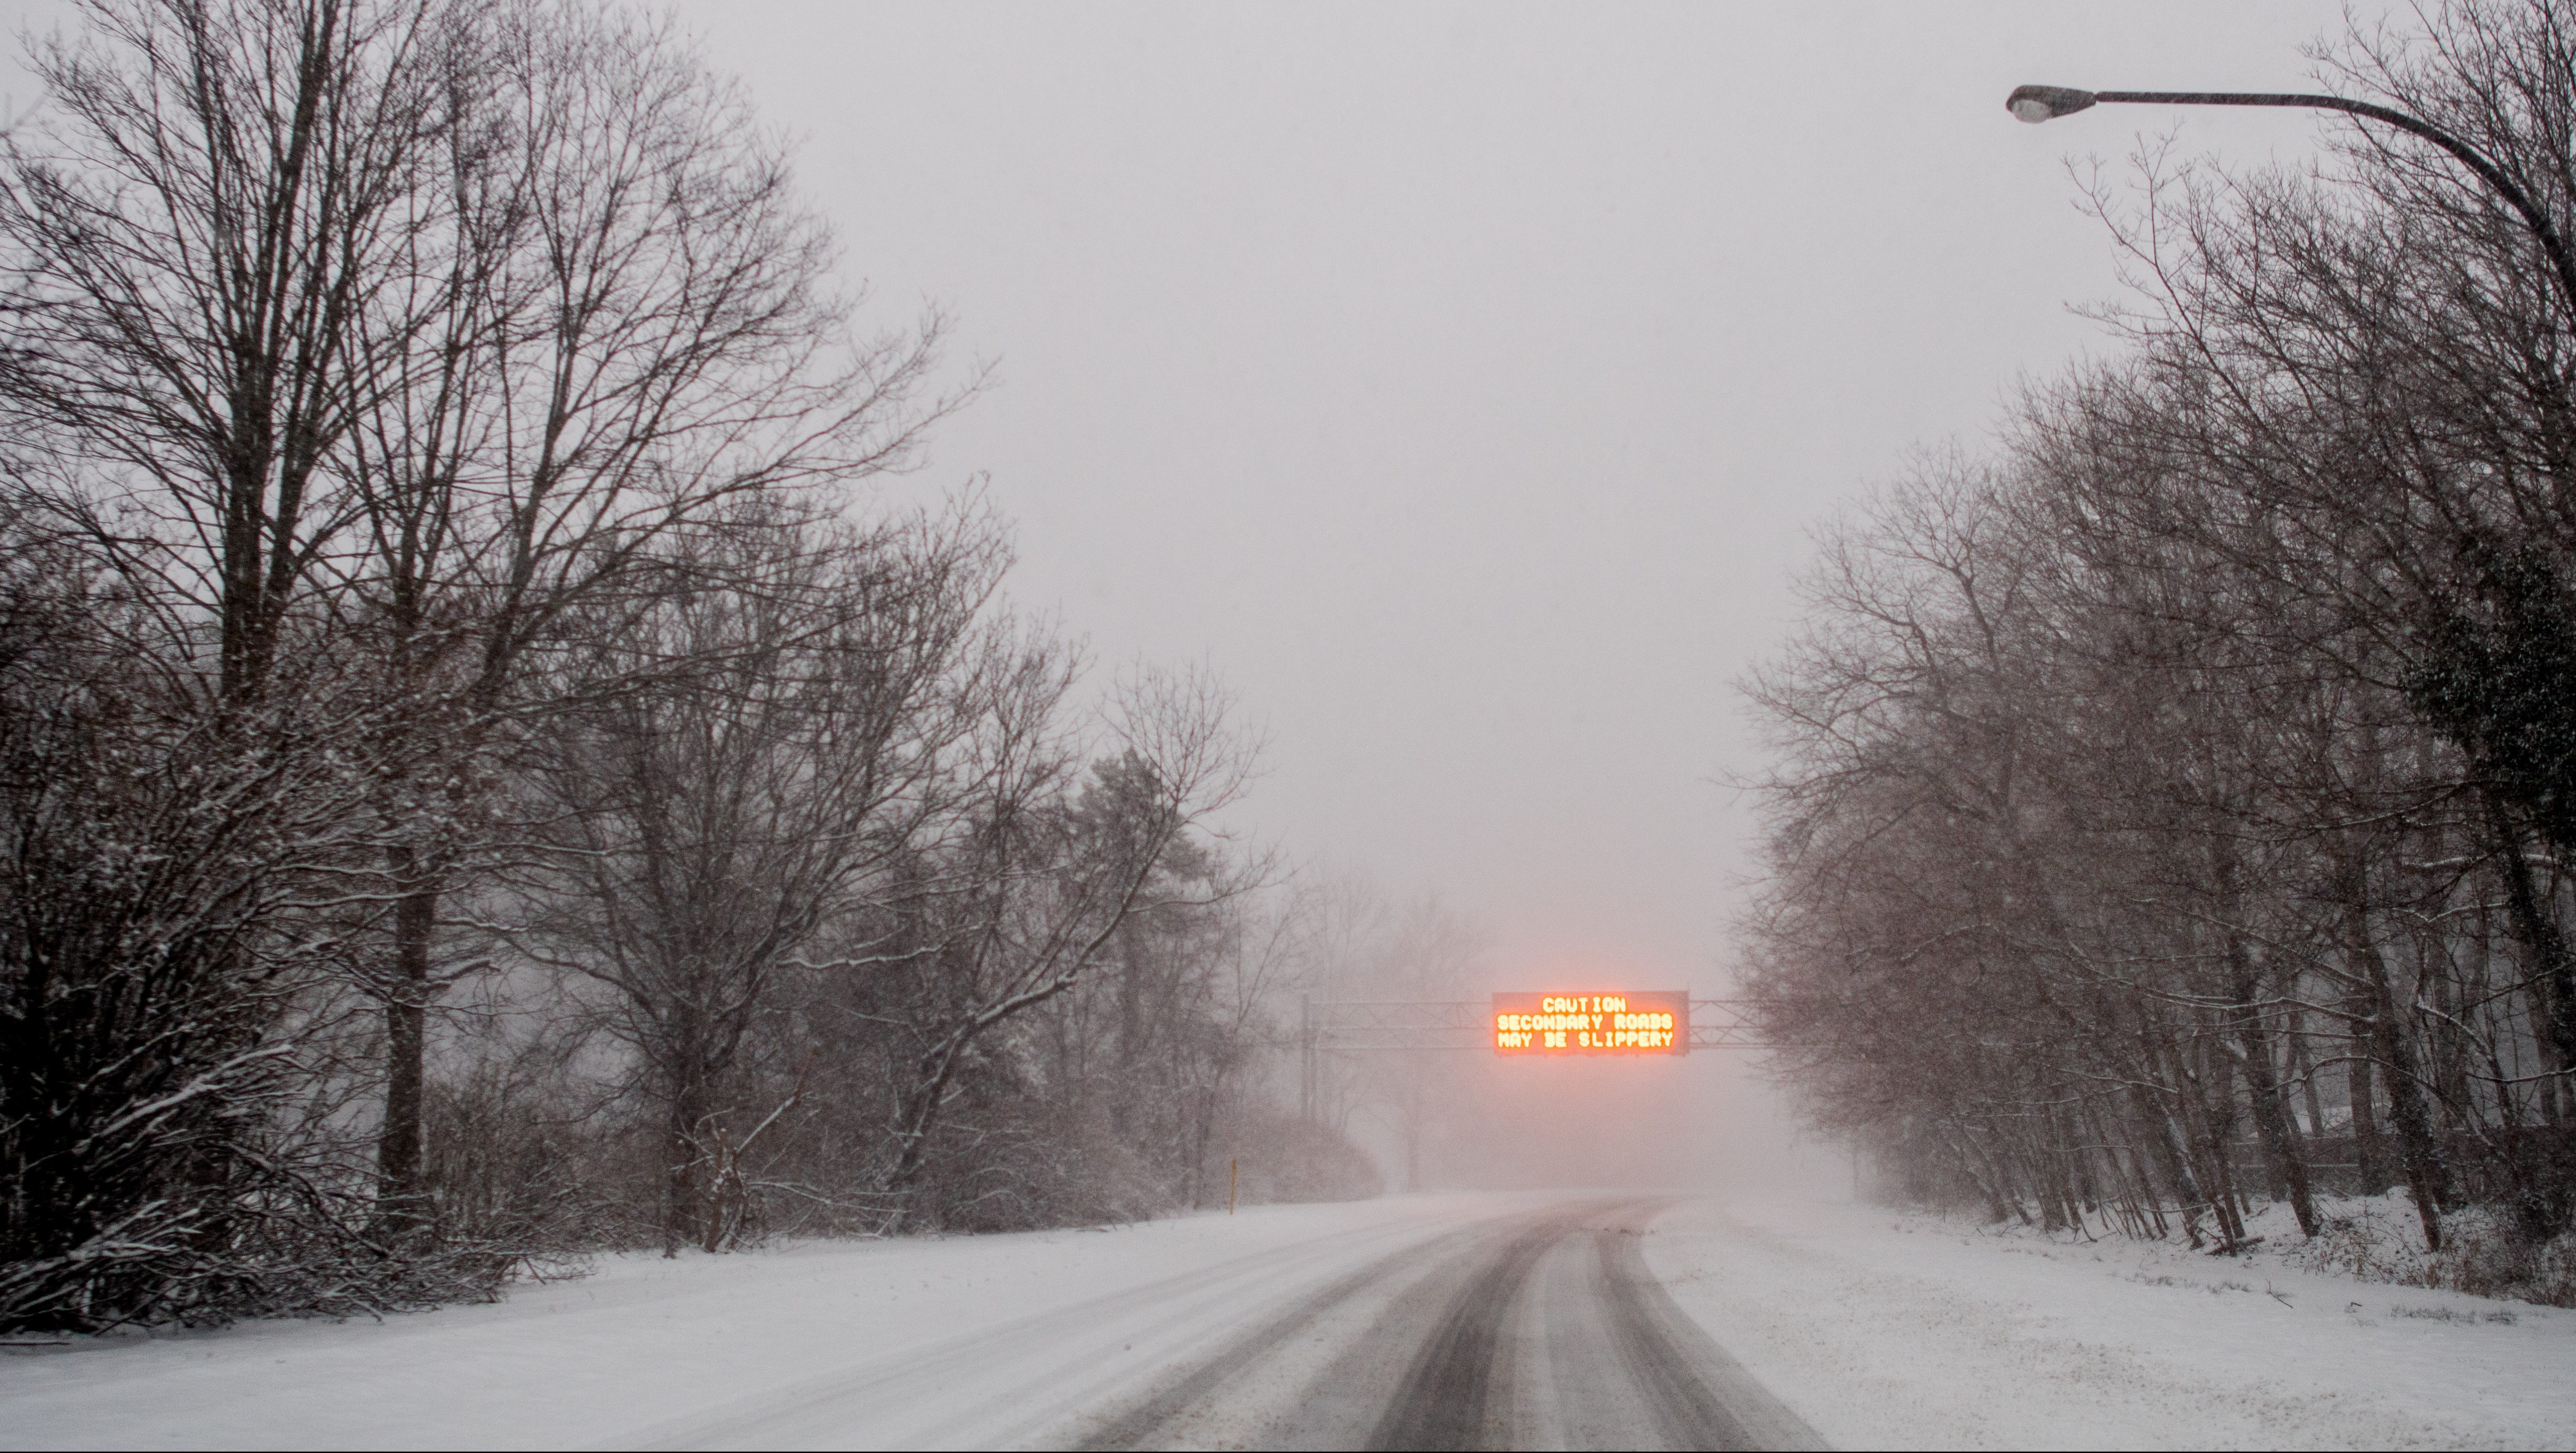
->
644;3;2370;989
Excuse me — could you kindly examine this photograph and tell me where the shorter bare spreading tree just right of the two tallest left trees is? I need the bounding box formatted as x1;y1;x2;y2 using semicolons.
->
494;515;1000;1249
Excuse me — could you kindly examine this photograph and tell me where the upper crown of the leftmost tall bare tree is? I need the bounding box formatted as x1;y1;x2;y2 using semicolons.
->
0;0;453;701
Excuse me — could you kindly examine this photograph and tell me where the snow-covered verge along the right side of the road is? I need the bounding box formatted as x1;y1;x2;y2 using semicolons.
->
1646;1203;2576;1448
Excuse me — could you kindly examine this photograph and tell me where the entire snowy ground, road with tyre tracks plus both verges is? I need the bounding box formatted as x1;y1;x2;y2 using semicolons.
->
0;1193;2576;1448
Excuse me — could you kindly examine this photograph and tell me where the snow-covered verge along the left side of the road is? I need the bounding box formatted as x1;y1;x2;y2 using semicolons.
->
0;1195;1515;1448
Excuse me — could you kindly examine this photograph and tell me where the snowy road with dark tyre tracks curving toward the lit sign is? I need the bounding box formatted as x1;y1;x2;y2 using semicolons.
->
634;1195;1821;1448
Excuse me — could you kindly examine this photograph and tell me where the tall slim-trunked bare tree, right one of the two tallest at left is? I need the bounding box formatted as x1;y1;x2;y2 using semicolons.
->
327;5;971;1205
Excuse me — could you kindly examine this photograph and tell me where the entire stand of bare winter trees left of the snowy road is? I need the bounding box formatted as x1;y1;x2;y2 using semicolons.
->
0;0;1355;1327
